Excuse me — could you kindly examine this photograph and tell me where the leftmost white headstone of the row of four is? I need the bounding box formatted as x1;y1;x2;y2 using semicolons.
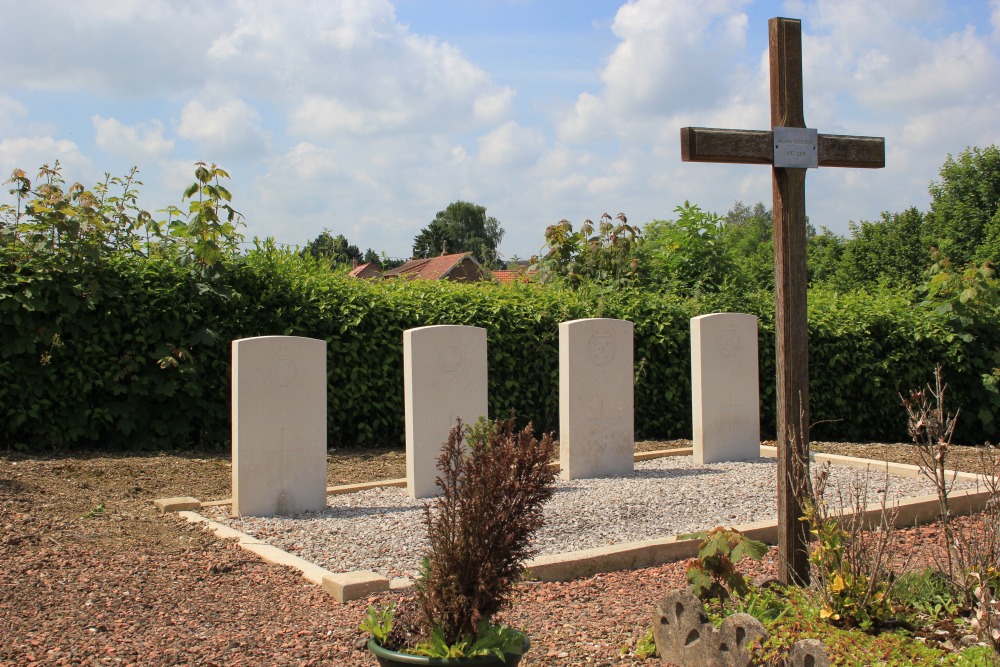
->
232;336;327;516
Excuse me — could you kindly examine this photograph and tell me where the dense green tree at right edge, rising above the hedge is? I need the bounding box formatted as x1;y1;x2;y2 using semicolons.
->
926;146;1000;265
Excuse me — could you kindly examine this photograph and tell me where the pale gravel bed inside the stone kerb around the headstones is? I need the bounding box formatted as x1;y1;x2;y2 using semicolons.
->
204;456;974;577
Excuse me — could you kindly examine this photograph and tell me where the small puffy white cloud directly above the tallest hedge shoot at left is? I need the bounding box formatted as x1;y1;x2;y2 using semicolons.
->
177;99;271;161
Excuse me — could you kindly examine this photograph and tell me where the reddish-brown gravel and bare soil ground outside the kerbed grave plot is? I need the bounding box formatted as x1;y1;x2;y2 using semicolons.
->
0;440;992;667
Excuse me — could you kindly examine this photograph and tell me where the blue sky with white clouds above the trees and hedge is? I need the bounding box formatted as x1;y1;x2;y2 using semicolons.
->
0;0;1000;258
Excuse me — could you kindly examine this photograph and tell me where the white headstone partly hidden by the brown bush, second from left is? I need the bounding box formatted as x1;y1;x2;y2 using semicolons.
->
403;325;489;498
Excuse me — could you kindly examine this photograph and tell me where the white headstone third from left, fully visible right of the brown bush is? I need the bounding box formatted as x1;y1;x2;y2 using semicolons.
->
559;319;635;479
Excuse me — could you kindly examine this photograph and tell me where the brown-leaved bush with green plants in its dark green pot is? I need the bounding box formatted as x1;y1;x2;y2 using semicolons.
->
360;416;556;667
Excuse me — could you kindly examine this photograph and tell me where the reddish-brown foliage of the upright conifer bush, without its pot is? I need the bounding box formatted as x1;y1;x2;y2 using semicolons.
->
417;416;556;644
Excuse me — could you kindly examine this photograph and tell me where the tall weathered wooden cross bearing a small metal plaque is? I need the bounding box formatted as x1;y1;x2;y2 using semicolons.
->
681;18;885;584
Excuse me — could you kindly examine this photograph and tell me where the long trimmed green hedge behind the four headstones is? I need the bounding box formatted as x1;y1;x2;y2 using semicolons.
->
0;247;1000;449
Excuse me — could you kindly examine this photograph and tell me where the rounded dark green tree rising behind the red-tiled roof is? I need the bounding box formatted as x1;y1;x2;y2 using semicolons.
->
413;201;504;268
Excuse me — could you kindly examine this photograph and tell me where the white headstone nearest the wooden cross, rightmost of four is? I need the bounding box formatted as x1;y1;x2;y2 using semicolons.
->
691;313;760;463
